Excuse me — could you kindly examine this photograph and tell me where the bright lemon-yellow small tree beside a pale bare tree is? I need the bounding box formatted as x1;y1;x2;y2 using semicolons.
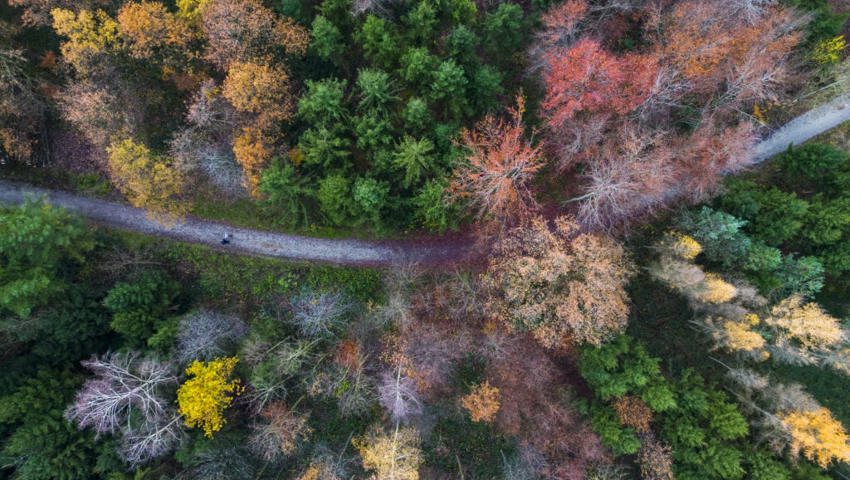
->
177;357;243;437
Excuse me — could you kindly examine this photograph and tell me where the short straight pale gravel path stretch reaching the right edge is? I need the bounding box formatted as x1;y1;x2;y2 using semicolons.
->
752;93;850;164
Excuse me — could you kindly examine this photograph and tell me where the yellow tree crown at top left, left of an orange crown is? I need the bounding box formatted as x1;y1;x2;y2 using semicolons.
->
51;8;119;72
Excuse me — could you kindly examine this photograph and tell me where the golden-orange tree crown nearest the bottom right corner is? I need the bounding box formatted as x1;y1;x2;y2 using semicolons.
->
781;407;850;468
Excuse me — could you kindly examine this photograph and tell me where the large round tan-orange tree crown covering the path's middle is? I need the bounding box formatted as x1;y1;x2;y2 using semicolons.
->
485;217;632;348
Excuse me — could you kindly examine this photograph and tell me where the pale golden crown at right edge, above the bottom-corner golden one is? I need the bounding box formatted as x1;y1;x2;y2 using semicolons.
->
764;295;846;349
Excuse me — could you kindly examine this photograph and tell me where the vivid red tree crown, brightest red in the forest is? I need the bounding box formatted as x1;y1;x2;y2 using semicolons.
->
542;39;658;127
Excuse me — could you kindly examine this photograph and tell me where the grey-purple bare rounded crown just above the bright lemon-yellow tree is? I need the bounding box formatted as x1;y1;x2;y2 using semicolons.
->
177;309;248;363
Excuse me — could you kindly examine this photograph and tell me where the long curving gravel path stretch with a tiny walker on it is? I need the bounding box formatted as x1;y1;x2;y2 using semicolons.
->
0;180;471;266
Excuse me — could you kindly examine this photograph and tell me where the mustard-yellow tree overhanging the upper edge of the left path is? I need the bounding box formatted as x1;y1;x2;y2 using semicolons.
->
107;138;188;222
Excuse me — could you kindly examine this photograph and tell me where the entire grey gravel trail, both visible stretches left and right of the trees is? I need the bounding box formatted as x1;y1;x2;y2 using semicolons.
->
0;94;850;266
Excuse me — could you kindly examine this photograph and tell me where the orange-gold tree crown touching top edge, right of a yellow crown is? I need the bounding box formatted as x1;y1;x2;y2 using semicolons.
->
117;0;193;59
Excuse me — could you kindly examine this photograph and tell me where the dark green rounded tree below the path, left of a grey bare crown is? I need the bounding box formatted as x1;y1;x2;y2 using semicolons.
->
103;270;180;346
